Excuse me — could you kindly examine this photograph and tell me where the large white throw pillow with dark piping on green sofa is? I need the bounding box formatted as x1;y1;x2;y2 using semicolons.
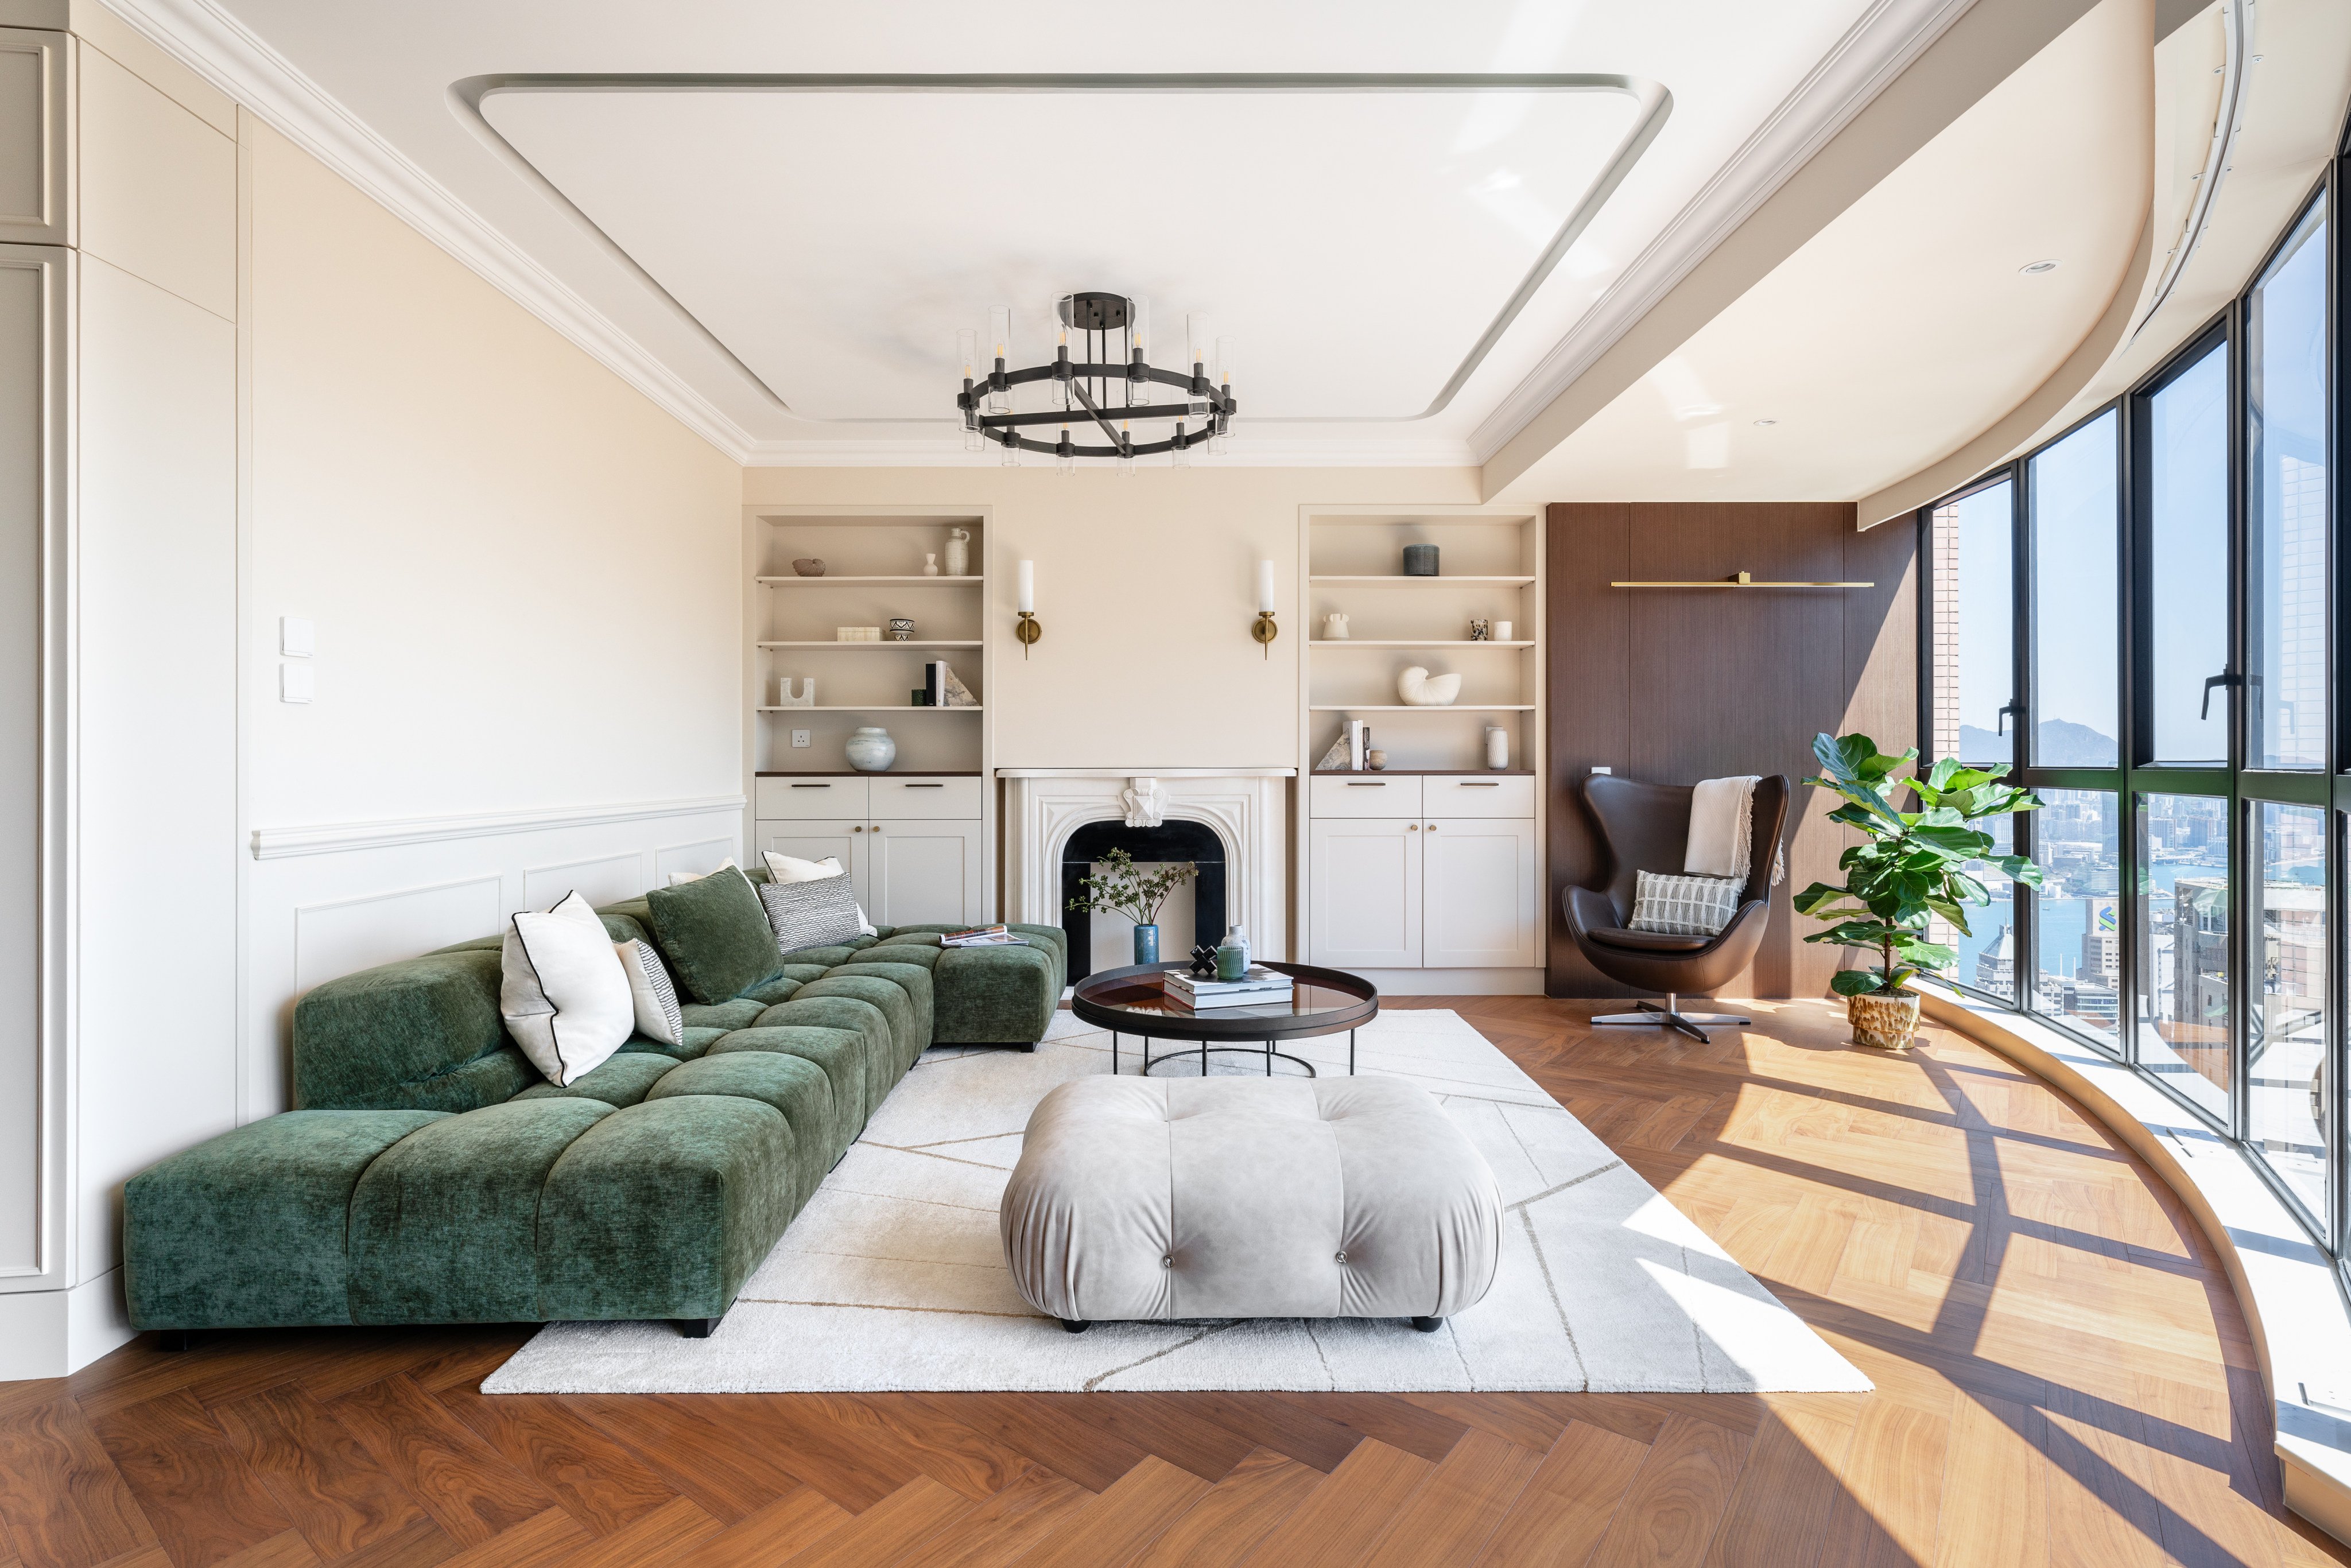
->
498;891;637;1086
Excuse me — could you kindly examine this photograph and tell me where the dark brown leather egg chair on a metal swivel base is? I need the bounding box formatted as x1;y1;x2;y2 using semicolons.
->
1559;774;1789;1039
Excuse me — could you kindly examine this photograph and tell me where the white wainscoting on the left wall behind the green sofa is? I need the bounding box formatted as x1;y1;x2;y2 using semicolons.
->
253;794;743;1121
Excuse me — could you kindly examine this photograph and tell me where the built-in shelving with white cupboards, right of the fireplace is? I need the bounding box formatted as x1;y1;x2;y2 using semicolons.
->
1300;508;1545;995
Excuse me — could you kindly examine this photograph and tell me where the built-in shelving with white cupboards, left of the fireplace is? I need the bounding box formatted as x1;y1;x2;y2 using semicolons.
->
743;506;995;924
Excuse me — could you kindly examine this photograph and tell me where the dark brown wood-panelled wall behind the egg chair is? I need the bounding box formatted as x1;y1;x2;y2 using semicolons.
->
1545;500;1918;997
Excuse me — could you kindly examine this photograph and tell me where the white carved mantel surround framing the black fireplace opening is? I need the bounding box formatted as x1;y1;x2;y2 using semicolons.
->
997;766;1298;959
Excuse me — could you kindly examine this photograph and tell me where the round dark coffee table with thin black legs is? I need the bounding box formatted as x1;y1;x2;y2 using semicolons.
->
1070;961;1380;1077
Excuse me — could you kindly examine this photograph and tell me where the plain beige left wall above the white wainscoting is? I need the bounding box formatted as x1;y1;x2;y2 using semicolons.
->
242;115;740;828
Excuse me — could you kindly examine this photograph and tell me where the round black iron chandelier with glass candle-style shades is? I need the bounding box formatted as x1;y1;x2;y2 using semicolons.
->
955;292;1236;472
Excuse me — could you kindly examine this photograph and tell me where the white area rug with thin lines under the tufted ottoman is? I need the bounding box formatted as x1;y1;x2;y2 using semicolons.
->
482;1011;1871;1394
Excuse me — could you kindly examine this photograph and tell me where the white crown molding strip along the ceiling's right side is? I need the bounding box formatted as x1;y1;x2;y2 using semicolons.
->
1469;0;1975;463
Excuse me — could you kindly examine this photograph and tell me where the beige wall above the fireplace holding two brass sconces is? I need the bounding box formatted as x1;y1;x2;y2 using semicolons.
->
743;465;1479;769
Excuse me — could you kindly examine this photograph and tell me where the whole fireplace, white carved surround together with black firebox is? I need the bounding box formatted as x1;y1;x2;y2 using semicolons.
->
997;769;1298;980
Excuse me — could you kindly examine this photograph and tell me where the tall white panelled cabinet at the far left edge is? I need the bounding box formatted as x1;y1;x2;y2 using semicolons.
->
0;0;242;1380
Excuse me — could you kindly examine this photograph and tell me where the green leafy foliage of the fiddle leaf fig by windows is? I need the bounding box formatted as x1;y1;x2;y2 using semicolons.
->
1796;736;2040;997
